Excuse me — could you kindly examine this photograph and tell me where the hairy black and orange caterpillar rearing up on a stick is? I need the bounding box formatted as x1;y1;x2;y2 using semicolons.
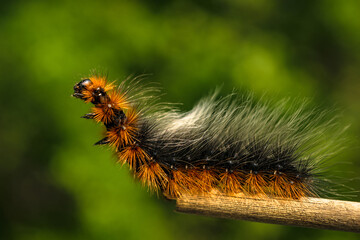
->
73;74;344;199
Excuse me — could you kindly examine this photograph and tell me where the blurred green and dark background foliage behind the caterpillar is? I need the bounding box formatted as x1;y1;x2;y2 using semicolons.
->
0;0;360;240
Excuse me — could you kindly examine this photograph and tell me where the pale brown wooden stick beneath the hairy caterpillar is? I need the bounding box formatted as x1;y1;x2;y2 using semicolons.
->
176;195;360;232
